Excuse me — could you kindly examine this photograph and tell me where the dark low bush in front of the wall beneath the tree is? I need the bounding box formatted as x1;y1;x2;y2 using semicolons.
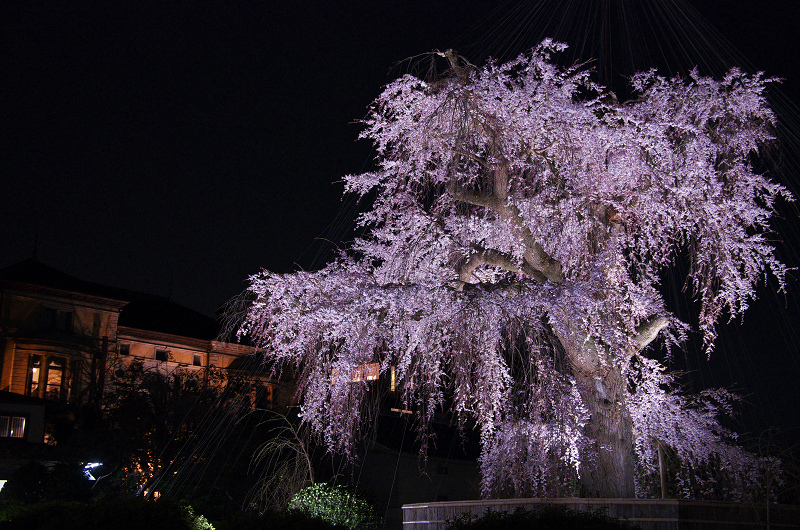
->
447;506;635;530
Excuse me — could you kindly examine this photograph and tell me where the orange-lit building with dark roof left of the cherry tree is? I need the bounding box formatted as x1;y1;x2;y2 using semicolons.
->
0;258;292;441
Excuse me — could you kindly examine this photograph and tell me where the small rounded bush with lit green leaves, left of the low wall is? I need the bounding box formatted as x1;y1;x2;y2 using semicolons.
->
289;483;382;530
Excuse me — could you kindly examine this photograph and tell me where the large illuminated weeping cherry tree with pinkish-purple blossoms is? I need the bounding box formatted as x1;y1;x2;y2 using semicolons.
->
242;41;788;497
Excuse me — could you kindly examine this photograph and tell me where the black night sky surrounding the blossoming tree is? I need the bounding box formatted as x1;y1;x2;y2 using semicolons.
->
0;0;800;442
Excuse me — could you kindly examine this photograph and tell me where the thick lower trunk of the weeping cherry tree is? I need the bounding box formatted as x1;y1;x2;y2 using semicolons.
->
573;358;636;498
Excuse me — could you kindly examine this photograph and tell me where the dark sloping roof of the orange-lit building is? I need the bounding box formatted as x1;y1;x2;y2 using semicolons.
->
0;257;219;340
